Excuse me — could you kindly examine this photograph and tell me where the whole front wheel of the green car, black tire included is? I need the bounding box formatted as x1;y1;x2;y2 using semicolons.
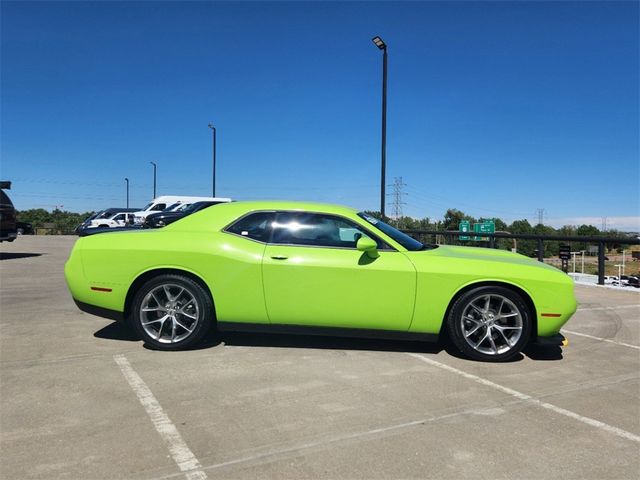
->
446;286;533;362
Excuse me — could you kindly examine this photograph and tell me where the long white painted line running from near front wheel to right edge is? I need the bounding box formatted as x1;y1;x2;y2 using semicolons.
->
407;353;640;443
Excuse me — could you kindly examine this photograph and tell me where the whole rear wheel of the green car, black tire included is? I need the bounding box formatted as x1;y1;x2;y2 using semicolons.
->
128;274;214;350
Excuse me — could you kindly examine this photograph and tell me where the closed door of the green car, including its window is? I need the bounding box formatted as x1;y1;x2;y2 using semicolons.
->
262;212;416;331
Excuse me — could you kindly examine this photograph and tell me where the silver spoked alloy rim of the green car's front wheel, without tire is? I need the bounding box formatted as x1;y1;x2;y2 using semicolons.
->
460;294;523;355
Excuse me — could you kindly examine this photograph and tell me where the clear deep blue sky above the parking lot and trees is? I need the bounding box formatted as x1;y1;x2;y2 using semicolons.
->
0;1;640;229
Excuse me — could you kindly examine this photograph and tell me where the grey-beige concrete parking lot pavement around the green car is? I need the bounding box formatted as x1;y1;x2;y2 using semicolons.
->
0;236;640;480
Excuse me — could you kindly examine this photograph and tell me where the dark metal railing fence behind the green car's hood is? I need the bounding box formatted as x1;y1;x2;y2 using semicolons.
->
403;230;640;285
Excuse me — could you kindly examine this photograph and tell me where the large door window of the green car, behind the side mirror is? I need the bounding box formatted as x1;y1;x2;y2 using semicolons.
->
271;212;386;249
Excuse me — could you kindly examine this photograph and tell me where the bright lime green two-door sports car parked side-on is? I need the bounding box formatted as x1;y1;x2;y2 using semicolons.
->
65;202;576;361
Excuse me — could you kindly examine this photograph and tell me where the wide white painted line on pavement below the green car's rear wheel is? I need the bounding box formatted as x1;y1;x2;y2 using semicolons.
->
113;355;207;480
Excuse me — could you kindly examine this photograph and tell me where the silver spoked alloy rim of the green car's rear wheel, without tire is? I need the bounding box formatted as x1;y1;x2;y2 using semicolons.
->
140;283;200;343
